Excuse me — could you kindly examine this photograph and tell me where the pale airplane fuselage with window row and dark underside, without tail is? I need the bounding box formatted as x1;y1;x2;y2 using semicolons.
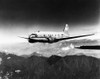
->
29;32;68;43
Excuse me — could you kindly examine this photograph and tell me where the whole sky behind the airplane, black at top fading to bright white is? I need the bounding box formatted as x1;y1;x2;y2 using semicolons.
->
0;0;100;43
